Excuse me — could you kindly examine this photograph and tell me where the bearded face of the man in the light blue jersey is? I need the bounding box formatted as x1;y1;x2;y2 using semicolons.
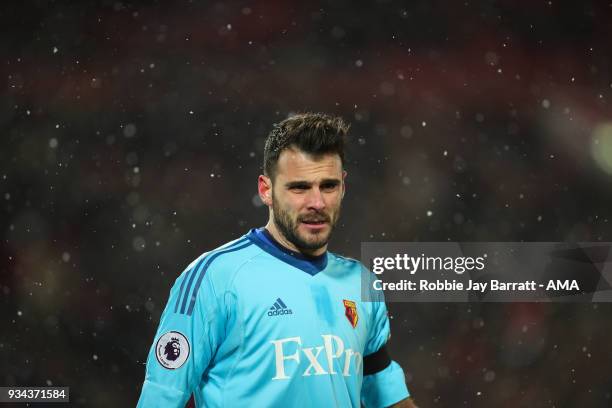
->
271;149;346;252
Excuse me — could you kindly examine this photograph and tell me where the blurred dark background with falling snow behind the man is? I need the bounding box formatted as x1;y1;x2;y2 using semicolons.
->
0;0;612;408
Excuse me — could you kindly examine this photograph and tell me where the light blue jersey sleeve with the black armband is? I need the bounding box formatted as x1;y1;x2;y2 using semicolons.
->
361;299;410;408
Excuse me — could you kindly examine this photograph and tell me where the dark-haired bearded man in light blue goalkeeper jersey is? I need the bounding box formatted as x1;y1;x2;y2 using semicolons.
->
138;113;414;408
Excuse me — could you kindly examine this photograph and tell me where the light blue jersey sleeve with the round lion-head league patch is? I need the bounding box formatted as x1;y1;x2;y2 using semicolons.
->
138;262;230;408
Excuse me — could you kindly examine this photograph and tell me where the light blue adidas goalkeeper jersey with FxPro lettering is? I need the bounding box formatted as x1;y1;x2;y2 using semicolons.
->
138;229;409;407
